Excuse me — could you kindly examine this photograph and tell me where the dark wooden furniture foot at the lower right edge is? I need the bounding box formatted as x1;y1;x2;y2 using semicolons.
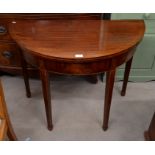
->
144;113;155;141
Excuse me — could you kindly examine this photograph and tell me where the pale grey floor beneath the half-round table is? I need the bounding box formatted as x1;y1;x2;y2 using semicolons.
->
1;76;155;141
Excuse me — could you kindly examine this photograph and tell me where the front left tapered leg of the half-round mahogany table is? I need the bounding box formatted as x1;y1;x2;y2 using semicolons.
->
39;61;53;130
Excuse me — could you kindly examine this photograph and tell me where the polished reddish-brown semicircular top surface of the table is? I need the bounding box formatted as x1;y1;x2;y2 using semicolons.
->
9;20;145;60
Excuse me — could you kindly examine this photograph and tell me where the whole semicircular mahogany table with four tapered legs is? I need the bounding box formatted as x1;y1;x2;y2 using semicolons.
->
9;20;145;130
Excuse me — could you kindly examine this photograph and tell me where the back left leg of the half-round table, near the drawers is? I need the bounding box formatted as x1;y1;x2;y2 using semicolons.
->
21;52;31;97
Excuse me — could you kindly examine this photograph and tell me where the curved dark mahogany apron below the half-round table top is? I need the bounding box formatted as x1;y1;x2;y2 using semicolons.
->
23;47;135;75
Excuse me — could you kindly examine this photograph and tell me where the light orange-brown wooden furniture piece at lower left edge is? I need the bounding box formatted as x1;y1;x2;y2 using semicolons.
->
0;81;17;140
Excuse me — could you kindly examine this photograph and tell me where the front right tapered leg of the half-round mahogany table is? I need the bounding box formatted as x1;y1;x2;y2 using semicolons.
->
102;69;116;131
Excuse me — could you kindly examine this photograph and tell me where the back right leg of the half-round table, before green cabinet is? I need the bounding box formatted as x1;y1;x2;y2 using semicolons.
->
121;57;133;96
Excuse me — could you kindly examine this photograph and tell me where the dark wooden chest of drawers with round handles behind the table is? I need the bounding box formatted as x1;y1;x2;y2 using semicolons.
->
0;13;111;83
